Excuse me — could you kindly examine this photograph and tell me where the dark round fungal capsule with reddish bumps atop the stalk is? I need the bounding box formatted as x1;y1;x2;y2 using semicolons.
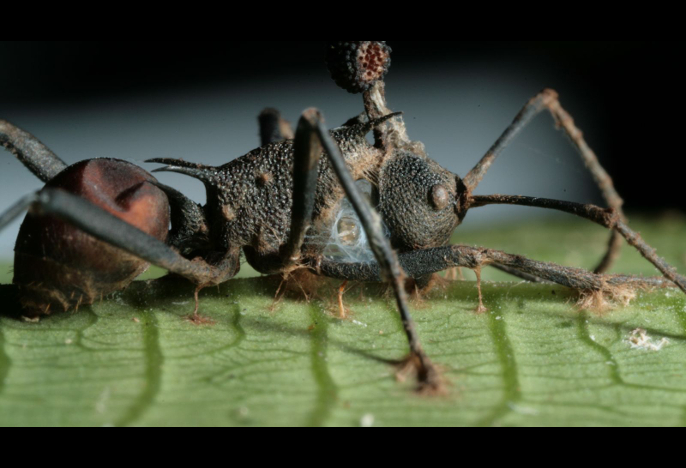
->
326;41;392;94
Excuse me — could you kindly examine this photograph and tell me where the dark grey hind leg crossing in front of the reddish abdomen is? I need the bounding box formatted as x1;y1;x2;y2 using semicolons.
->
0;189;239;288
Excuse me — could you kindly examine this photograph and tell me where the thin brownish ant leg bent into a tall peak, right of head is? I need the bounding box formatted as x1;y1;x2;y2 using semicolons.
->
464;89;626;273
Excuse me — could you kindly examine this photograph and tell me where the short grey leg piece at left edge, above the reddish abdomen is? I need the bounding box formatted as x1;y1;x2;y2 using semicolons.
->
0;120;67;182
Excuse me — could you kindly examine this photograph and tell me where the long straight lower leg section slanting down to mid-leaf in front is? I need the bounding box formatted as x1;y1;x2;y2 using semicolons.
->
301;109;441;392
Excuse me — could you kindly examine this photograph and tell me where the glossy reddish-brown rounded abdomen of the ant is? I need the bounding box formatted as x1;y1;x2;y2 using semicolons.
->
14;159;169;316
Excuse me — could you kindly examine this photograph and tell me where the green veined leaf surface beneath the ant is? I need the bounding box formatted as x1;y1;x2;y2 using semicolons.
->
0;219;686;426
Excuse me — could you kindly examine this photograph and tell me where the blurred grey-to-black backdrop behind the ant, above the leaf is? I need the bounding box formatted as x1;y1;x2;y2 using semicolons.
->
0;41;684;261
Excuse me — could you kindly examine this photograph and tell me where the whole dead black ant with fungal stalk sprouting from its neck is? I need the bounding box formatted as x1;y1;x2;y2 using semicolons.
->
0;41;686;393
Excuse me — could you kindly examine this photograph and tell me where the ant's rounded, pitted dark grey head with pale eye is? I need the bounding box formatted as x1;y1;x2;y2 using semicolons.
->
379;151;466;252
